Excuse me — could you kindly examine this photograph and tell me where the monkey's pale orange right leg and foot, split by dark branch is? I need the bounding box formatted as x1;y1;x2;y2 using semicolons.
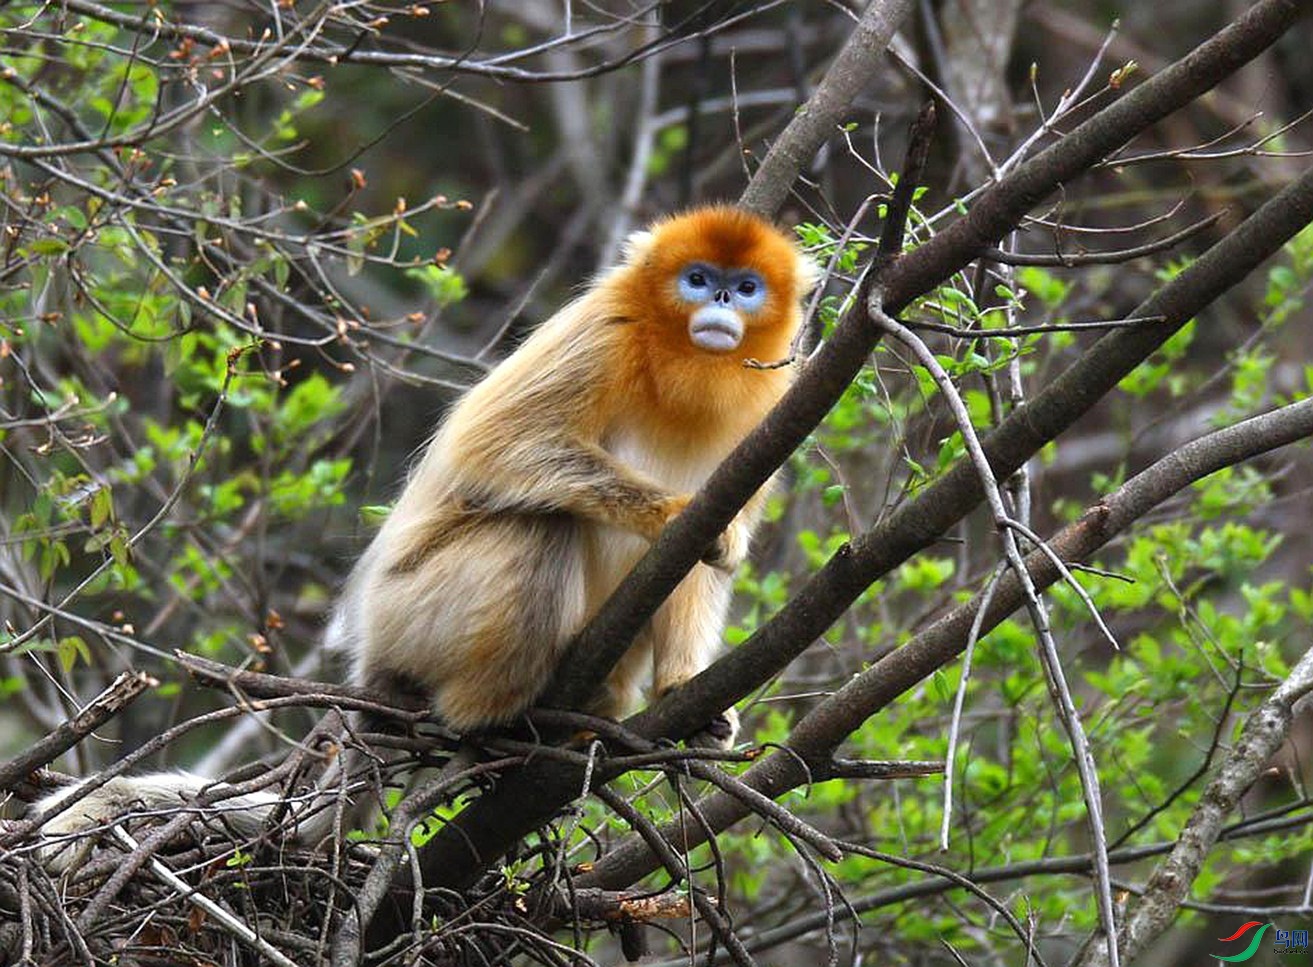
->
651;565;738;749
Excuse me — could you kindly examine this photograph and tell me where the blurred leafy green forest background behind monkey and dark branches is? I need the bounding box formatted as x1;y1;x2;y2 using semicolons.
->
0;0;1313;964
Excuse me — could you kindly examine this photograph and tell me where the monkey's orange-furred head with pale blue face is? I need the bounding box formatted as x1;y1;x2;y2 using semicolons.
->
625;205;815;361
